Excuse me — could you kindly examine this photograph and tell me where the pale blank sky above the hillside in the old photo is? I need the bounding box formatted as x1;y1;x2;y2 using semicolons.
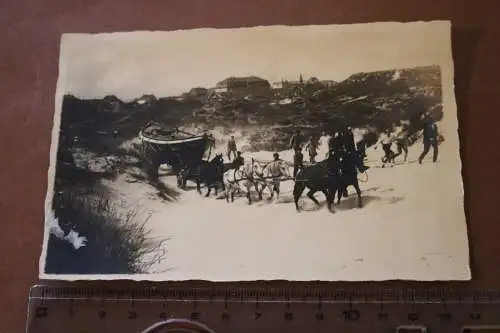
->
59;21;450;100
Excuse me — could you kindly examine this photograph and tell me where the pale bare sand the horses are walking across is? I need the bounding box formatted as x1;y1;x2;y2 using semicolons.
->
103;127;468;281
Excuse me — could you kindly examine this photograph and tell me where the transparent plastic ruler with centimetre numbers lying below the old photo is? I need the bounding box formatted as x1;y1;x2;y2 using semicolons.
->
27;285;500;333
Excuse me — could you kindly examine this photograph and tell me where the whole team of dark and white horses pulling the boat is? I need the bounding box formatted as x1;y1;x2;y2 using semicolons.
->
178;148;362;212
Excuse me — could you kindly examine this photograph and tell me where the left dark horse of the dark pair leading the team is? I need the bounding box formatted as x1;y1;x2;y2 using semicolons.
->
293;156;340;213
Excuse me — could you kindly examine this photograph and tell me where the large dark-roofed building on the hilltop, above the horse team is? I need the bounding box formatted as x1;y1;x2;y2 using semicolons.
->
216;76;272;97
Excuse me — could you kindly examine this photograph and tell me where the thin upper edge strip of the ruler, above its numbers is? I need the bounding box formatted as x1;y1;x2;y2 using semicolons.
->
28;283;500;307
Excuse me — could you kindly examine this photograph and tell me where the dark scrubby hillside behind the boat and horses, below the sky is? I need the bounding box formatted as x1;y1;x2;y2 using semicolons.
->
56;66;442;167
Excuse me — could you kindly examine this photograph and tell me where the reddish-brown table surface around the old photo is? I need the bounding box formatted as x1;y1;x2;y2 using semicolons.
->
0;0;500;333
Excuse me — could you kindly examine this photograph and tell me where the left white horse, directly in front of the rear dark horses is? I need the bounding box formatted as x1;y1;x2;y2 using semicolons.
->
223;159;262;205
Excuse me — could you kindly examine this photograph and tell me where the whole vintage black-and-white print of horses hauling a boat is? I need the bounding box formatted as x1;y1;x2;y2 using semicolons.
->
40;21;470;281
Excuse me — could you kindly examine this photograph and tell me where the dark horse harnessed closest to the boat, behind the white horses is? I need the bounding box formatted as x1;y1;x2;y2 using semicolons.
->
183;154;224;197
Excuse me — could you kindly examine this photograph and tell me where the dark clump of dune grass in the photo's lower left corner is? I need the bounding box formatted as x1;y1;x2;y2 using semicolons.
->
46;185;166;274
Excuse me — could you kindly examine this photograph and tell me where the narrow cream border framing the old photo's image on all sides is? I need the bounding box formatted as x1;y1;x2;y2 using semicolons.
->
39;20;471;282
